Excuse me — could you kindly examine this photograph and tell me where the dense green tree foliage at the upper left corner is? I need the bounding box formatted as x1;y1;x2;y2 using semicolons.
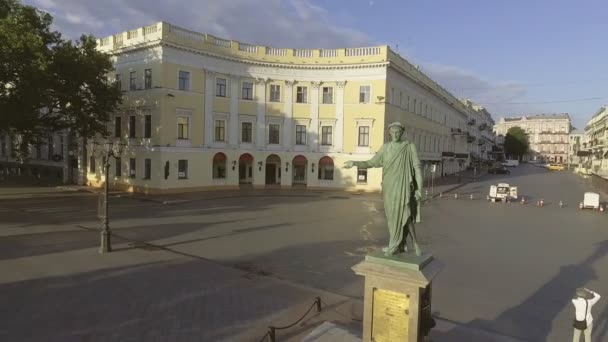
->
0;0;122;157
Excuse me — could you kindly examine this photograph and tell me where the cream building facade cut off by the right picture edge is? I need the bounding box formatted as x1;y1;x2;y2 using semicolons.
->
579;106;608;177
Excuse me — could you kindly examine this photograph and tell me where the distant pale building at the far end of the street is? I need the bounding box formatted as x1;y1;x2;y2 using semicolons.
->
494;114;571;163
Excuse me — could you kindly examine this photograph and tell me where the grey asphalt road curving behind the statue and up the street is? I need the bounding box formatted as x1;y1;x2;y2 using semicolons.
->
0;165;608;341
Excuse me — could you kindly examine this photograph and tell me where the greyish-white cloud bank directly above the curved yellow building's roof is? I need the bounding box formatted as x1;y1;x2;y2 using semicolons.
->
25;0;370;48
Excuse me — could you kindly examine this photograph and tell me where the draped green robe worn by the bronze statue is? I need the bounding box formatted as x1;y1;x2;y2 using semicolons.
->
356;141;422;252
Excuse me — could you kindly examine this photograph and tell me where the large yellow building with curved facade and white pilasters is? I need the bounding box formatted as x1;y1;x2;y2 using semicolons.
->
87;22;484;192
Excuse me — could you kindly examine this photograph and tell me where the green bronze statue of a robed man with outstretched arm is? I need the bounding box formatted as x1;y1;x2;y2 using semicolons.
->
344;122;422;256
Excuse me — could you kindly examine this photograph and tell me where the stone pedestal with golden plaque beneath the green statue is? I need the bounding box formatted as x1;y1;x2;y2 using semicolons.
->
352;252;442;342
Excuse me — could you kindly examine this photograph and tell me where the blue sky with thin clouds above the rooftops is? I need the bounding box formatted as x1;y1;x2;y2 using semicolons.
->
23;0;608;129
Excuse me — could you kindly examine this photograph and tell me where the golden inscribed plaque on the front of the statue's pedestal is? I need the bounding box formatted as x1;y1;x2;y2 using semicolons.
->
371;289;410;342
